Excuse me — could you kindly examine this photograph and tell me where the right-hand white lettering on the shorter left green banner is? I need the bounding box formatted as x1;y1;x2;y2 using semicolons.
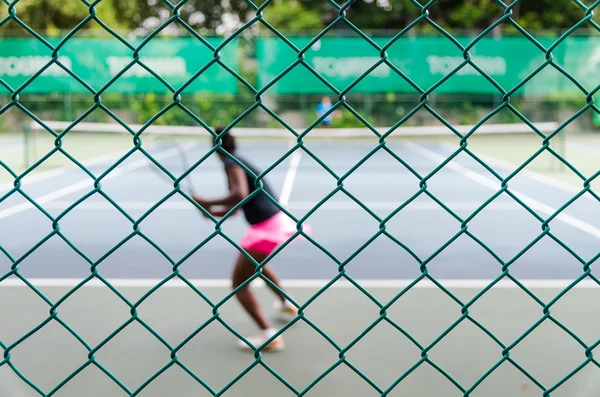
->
106;57;187;77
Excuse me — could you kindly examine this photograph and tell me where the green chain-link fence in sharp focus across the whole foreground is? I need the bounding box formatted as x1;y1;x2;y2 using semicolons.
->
0;0;600;396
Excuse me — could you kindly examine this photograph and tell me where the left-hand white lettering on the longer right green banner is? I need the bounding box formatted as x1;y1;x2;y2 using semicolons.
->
312;57;390;79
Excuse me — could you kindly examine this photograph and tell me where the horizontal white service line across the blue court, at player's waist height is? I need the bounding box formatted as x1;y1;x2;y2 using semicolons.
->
39;200;522;211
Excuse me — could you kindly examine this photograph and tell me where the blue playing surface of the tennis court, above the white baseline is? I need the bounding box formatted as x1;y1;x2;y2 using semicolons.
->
0;138;600;280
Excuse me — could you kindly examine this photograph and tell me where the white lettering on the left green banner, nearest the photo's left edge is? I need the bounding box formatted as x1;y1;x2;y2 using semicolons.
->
0;56;72;77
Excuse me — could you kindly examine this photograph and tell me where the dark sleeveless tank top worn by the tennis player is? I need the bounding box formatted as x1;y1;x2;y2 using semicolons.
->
224;154;280;225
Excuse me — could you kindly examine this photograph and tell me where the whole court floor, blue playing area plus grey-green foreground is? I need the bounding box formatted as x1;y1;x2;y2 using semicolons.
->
0;138;600;397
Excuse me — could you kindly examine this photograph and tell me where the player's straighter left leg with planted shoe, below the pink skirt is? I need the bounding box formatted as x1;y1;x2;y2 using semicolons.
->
232;252;284;351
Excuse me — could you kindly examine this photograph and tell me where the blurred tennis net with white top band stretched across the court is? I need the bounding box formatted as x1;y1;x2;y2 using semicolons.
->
19;121;566;175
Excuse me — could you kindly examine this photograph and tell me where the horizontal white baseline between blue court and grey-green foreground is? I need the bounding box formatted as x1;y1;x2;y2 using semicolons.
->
0;278;600;290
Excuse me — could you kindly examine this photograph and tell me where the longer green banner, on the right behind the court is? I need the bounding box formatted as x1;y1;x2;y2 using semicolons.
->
257;37;600;95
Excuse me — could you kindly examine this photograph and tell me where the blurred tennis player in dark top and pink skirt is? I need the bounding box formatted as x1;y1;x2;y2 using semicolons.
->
193;127;310;351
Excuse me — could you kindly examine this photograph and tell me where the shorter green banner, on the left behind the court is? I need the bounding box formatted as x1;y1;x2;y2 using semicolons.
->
0;38;238;94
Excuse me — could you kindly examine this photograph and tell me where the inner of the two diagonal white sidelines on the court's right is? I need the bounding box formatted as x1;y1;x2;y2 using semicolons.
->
406;143;600;239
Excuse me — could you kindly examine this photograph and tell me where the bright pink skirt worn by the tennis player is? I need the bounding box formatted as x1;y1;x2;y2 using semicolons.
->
240;212;312;255
